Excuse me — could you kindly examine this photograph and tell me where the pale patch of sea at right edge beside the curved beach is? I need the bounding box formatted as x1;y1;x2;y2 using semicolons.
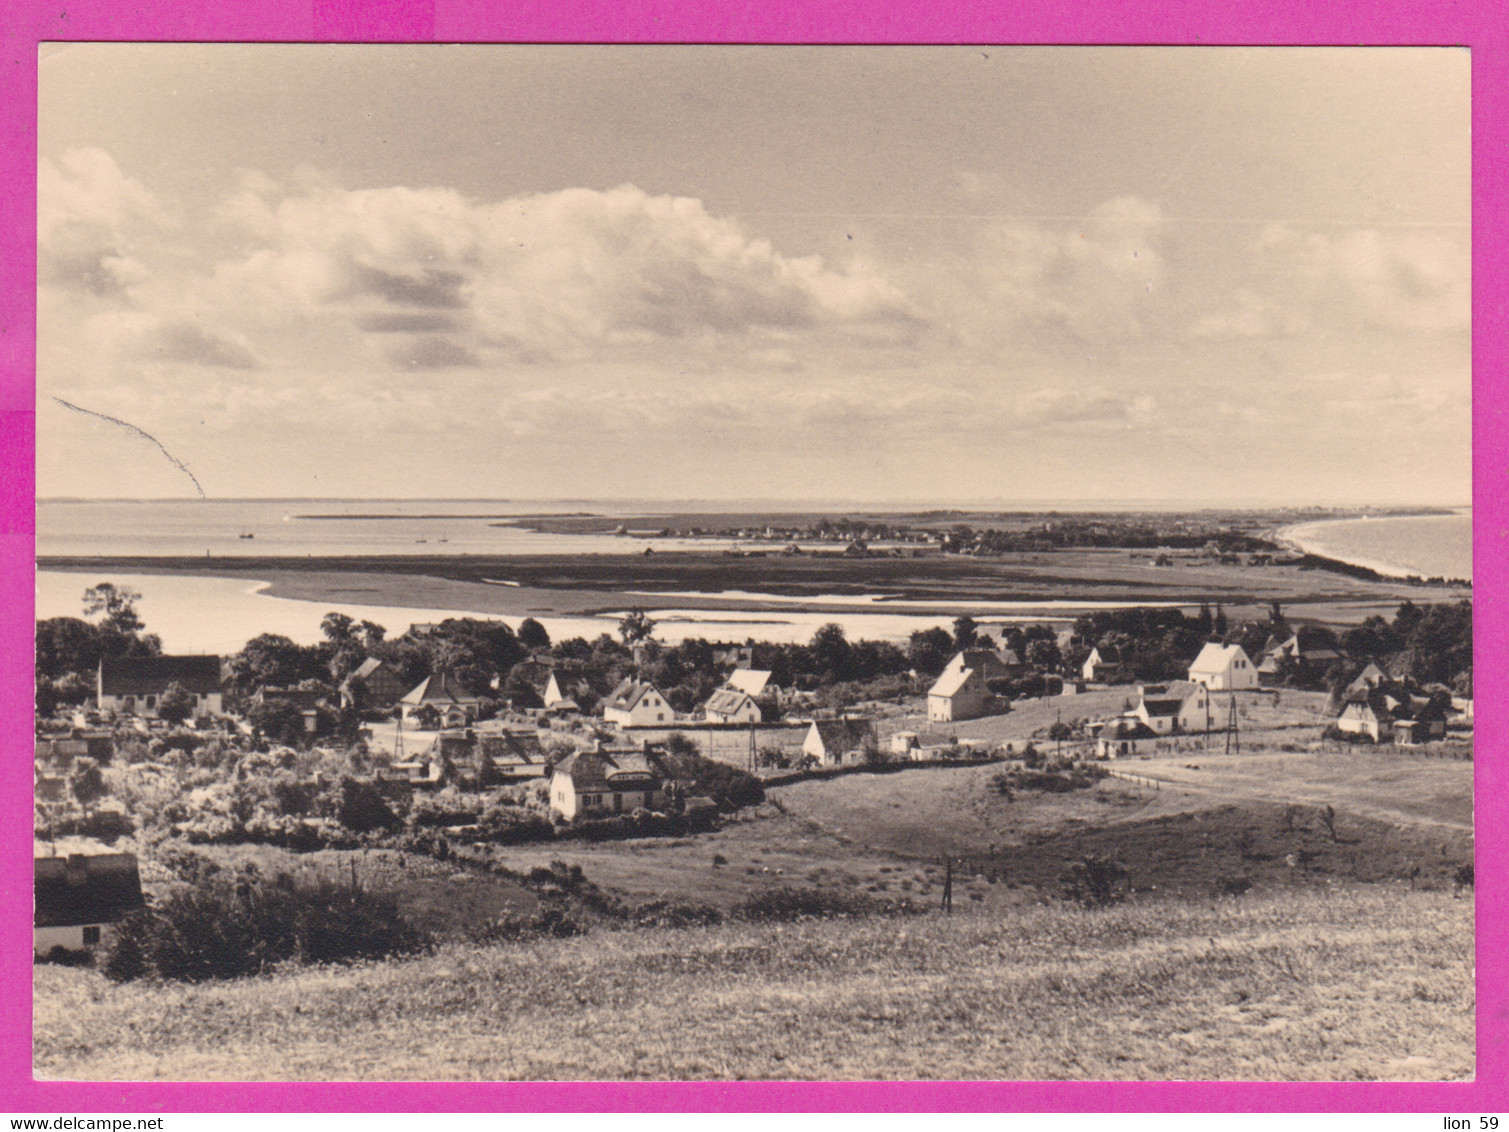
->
1284;512;1473;578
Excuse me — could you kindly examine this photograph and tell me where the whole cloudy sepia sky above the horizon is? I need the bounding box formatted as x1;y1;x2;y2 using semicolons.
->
38;44;1471;506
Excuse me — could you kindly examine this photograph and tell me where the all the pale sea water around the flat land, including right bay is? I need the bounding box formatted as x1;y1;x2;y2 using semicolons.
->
36;500;1471;655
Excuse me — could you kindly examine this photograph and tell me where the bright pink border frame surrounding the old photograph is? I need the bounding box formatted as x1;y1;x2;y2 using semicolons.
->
0;0;1509;1115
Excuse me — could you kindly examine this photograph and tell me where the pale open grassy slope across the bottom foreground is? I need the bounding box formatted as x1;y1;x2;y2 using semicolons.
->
35;884;1474;1081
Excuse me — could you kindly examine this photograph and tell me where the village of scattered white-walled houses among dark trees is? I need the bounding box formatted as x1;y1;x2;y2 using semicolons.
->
35;584;1473;961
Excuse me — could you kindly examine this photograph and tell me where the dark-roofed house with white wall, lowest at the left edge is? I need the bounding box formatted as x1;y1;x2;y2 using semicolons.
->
32;838;145;957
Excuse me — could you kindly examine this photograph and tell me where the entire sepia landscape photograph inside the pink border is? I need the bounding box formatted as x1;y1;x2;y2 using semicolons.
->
32;42;1486;1082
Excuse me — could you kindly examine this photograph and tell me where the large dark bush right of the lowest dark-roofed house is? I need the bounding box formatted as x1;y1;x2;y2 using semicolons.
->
103;868;430;983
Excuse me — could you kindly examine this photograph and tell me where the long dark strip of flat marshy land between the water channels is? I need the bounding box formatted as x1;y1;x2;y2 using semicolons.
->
38;549;1471;623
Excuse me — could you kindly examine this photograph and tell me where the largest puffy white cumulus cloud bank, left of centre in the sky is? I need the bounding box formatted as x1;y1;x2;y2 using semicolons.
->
203;181;917;368
